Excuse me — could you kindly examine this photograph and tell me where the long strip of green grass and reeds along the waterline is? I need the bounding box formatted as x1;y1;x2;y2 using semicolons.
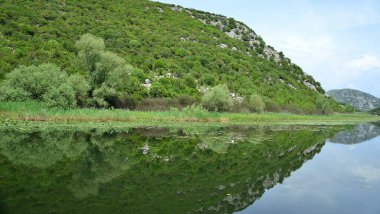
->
0;102;380;126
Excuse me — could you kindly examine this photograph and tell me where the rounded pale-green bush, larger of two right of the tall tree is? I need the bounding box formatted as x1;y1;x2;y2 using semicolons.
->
202;85;232;112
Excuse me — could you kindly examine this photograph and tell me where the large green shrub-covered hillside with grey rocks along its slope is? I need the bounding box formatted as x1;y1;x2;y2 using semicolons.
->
0;0;339;113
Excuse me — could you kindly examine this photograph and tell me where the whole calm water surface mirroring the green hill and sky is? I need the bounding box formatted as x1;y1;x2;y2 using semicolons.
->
0;124;380;214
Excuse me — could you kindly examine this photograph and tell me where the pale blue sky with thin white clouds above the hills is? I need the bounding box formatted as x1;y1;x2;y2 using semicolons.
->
155;0;380;97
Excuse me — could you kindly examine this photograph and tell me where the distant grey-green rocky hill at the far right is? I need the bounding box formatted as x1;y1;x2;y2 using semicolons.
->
327;89;380;111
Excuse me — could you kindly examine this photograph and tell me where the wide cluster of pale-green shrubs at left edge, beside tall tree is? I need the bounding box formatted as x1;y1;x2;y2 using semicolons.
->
0;64;88;108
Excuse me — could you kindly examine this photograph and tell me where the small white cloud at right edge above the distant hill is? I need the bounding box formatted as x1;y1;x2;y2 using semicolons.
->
347;55;380;72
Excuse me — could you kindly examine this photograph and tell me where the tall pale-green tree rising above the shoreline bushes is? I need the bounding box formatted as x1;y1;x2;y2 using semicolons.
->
76;34;147;107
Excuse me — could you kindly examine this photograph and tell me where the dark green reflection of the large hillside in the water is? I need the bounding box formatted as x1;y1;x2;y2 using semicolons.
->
0;126;376;213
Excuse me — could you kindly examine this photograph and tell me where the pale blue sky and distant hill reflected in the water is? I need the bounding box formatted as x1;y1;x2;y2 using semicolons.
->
238;124;380;214
